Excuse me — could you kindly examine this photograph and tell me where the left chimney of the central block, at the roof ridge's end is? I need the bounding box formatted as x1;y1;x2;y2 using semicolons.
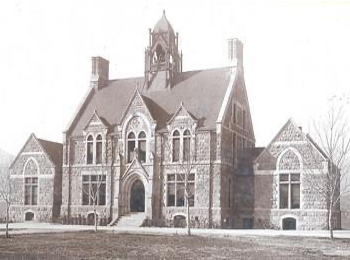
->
90;57;109;90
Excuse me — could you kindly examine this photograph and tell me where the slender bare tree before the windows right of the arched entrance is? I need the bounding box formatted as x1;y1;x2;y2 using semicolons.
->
164;132;195;236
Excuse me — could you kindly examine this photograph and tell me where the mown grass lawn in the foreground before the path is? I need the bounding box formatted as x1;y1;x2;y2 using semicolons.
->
0;231;350;260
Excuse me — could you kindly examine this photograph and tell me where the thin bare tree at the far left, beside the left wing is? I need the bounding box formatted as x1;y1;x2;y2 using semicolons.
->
0;168;19;238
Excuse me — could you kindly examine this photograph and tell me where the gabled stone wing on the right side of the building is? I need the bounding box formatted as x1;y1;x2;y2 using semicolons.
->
254;119;340;229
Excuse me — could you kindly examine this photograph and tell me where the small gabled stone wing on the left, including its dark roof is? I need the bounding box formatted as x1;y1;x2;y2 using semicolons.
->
10;134;62;222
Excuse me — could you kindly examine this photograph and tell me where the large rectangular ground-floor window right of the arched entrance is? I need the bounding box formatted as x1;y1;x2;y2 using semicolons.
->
167;173;195;207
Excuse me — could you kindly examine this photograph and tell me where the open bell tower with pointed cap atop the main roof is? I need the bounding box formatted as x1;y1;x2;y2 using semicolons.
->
145;11;182;91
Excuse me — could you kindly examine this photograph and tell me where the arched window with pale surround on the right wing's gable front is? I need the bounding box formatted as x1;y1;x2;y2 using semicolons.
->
278;150;300;209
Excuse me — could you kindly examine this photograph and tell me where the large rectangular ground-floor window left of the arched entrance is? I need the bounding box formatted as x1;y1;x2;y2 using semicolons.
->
82;175;106;205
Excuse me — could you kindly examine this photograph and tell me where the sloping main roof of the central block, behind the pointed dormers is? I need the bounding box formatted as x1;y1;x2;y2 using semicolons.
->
73;67;231;134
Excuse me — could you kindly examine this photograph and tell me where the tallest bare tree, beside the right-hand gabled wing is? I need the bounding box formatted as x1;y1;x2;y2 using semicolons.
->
305;98;350;239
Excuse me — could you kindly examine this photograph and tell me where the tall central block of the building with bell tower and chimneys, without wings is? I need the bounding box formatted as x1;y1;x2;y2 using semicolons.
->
61;14;255;227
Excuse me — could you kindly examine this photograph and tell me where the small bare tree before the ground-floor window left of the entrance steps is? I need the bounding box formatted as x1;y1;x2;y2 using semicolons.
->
81;174;106;232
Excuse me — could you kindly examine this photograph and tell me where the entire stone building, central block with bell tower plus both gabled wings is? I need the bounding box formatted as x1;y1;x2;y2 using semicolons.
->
6;14;340;232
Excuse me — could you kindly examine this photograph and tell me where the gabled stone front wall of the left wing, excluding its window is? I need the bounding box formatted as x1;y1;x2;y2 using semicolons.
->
11;135;61;222
